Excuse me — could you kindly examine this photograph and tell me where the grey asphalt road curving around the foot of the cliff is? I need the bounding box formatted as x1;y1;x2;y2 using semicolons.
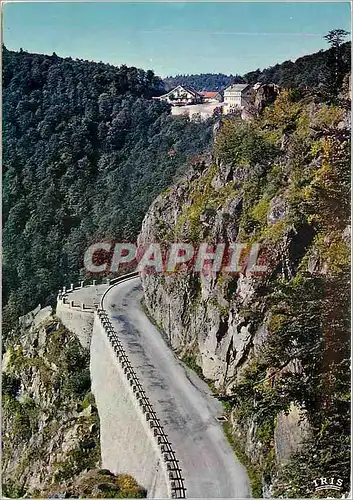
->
103;278;250;498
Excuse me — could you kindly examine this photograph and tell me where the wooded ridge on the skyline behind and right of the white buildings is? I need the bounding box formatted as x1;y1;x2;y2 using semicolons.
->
164;42;351;91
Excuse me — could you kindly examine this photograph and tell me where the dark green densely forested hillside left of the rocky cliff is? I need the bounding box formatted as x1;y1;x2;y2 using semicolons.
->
3;48;212;329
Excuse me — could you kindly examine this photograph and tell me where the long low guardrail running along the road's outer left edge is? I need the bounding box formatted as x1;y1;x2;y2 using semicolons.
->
97;272;186;498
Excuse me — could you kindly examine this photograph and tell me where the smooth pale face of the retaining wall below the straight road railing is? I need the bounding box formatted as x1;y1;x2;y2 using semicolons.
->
90;314;170;498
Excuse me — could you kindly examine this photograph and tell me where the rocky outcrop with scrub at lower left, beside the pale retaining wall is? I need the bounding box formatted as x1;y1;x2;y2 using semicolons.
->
2;307;145;498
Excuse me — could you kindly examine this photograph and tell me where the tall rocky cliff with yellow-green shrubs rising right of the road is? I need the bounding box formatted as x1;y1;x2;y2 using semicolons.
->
139;92;349;496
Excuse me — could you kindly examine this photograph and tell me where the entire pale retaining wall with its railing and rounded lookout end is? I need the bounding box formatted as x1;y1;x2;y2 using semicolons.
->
56;273;186;498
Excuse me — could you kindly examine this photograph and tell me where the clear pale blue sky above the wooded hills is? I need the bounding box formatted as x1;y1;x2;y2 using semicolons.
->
3;2;350;76
